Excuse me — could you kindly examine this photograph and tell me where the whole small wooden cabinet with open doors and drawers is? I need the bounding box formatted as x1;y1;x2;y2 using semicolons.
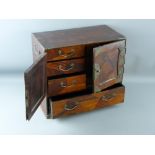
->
25;25;126;120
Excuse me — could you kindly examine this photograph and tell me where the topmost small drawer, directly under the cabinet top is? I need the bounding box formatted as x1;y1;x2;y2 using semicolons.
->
47;45;85;61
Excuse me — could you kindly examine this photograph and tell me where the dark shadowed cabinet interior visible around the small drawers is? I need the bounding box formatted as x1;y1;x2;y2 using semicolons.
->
47;41;122;101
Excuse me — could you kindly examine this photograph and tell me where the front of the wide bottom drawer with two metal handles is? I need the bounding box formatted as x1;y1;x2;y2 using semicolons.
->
51;86;125;118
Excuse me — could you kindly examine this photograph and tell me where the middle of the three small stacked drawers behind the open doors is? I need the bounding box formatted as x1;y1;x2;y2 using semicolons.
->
47;59;85;76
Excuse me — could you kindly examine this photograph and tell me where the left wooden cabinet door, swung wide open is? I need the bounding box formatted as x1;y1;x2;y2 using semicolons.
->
24;54;47;120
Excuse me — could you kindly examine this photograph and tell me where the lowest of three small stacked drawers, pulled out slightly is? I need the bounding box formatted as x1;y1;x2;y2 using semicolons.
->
48;75;86;96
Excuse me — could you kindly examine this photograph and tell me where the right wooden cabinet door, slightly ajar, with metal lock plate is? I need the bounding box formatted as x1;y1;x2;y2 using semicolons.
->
93;40;126;92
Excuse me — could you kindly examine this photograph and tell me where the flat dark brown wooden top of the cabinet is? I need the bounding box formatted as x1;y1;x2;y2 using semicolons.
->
33;25;125;49
